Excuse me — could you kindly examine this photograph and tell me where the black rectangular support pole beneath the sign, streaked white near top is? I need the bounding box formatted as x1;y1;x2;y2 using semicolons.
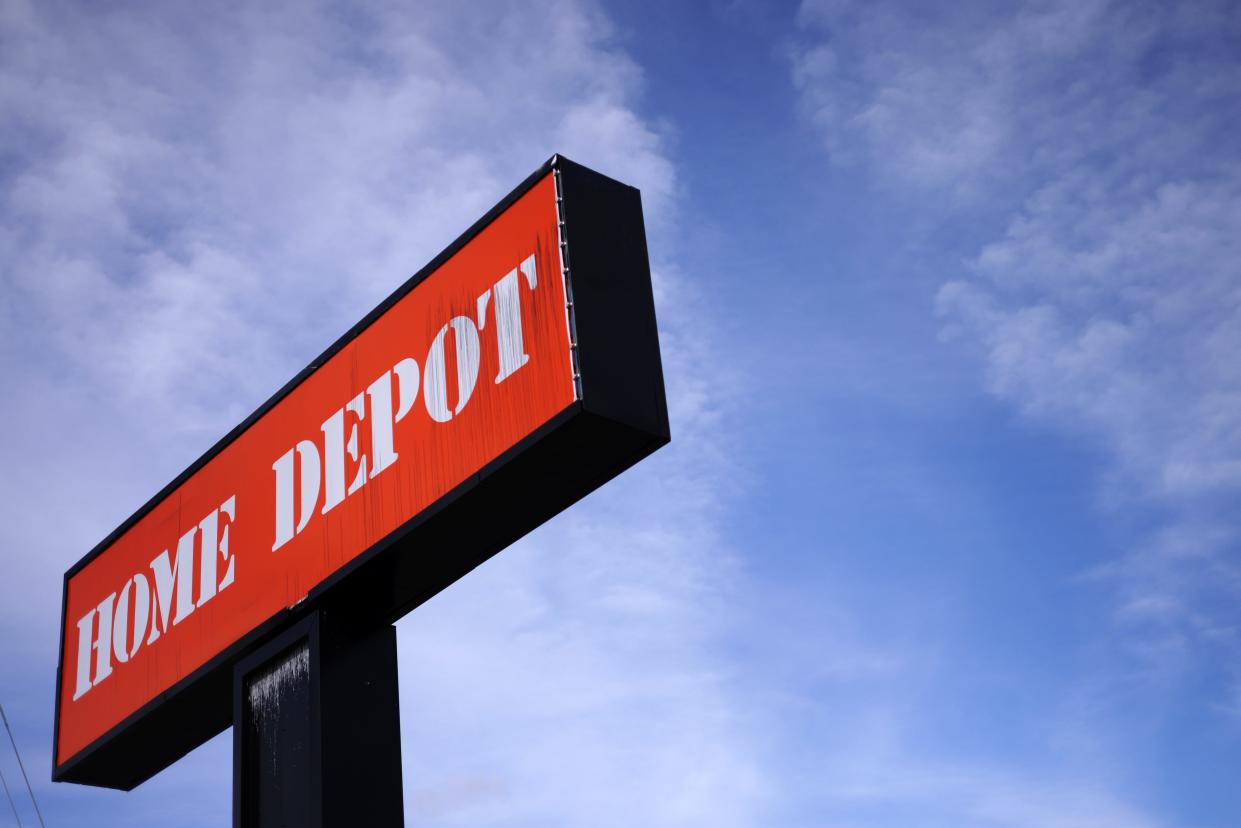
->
233;610;403;828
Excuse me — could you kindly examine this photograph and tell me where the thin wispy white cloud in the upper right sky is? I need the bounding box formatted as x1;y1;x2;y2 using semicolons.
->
794;0;1241;670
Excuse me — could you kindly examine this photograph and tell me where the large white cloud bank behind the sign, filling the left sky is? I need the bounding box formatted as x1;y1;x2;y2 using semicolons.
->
0;0;763;826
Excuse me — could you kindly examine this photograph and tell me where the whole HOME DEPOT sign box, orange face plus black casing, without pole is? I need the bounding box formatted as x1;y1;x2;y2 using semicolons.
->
53;158;666;787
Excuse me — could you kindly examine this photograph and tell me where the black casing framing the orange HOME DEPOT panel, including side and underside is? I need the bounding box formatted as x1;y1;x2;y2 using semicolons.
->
52;154;670;791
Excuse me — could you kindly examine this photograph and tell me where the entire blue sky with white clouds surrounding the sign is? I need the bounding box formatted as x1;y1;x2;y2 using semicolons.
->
0;0;1241;828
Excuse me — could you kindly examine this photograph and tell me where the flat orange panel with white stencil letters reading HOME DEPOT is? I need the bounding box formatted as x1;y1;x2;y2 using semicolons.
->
56;171;578;766
